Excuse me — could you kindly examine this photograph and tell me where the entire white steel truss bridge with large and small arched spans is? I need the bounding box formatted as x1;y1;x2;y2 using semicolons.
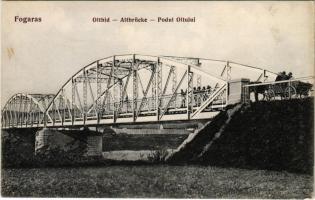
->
1;54;276;128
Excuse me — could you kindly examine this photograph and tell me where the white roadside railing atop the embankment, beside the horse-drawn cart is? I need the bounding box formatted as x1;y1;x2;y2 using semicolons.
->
242;76;314;103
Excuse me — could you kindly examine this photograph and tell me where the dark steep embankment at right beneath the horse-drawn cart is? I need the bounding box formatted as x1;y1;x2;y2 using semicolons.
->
169;98;314;174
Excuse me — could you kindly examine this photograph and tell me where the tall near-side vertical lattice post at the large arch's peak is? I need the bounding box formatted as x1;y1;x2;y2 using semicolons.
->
132;55;138;122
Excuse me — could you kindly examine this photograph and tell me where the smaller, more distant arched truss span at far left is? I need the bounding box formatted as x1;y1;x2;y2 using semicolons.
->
1;93;55;127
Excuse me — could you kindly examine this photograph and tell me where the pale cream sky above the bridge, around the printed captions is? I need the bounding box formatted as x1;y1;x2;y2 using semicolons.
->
1;1;314;106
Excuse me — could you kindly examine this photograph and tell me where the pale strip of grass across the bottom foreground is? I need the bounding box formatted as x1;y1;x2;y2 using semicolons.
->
2;165;313;199
